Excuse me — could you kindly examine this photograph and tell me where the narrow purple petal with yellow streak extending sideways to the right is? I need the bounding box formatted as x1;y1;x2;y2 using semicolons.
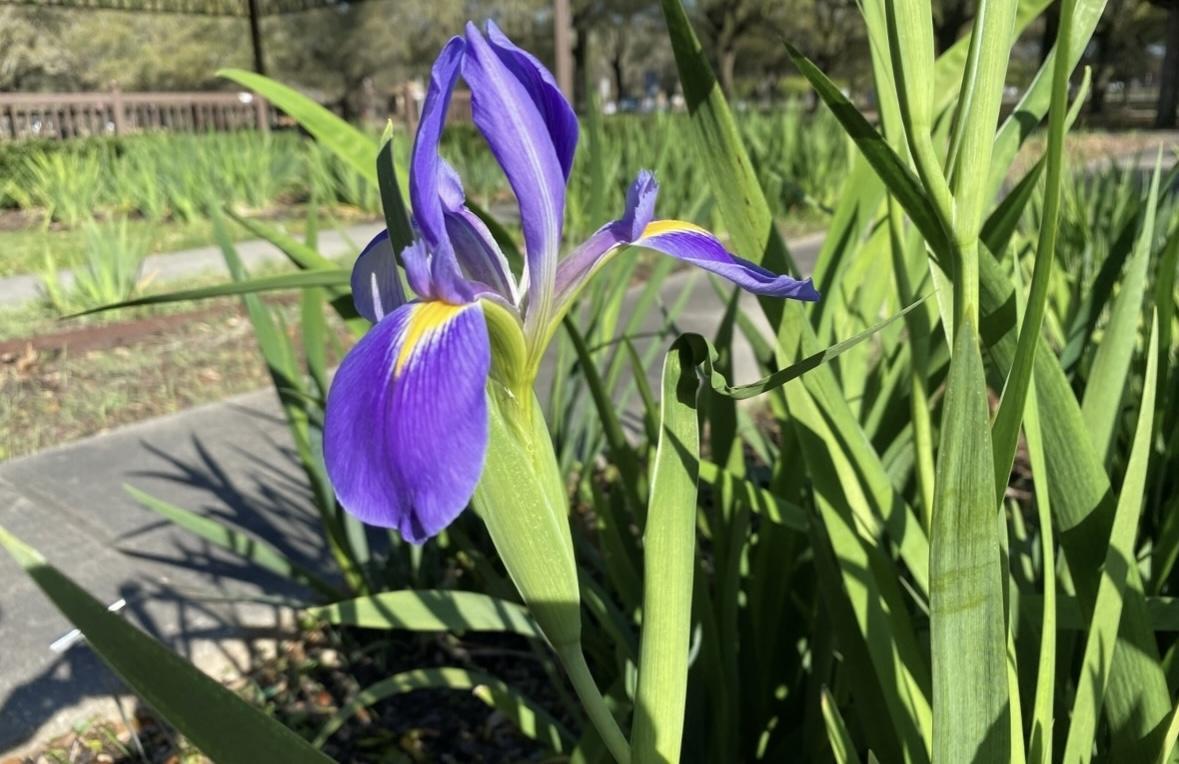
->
631;220;818;301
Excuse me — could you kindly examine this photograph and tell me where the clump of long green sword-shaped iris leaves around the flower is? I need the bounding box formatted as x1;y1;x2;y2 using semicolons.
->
0;0;1179;762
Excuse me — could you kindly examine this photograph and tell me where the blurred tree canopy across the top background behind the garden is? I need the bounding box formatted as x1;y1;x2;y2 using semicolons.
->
0;0;1179;123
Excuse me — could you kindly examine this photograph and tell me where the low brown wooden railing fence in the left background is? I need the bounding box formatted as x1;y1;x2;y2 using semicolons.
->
0;91;274;139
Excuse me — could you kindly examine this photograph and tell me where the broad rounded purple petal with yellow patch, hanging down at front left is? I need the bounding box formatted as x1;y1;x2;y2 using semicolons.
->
324;302;490;544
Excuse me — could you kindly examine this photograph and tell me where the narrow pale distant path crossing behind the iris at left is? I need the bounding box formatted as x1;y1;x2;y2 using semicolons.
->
0;223;384;308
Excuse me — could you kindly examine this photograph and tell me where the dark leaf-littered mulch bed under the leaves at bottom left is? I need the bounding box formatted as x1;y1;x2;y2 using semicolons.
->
4;624;572;764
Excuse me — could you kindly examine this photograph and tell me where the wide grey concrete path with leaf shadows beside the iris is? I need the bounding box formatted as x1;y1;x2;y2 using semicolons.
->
0;237;821;755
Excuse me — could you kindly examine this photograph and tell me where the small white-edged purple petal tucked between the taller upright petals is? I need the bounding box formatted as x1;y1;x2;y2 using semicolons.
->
440;160;518;303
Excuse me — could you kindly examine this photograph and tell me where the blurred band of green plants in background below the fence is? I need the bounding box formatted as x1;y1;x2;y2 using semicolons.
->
0;109;851;277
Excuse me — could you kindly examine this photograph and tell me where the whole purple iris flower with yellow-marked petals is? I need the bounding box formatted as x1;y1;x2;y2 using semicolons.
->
324;21;818;542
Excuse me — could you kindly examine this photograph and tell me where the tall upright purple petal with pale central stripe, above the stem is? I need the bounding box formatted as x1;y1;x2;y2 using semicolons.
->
462;24;565;325
